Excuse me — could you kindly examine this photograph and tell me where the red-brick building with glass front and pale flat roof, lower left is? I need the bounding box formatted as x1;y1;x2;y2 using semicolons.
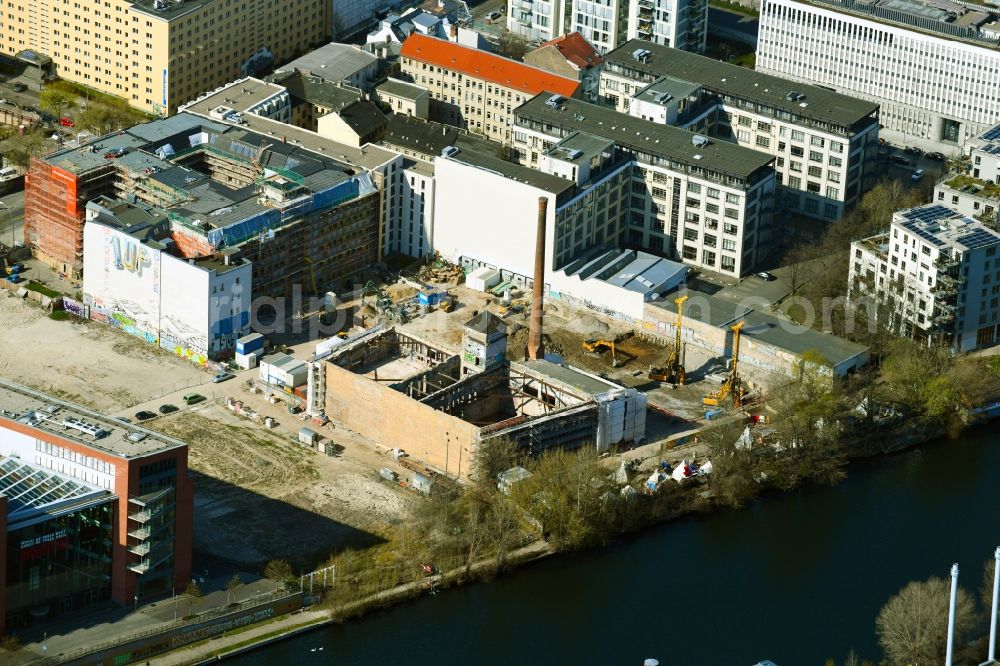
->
0;380;194;634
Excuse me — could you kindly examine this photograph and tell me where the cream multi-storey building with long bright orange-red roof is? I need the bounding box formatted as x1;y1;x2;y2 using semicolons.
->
399;33;580;143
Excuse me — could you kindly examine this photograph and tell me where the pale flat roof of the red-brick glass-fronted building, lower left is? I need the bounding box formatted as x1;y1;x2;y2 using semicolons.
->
0;379;187;459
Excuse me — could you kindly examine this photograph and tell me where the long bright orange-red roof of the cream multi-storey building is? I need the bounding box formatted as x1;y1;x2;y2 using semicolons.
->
400;33;580;97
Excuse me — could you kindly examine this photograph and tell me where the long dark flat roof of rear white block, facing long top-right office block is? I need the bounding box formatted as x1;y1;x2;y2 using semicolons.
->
604;39;879;128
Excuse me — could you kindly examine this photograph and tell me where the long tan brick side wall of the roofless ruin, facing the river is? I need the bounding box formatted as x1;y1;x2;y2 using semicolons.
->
325;363;478;477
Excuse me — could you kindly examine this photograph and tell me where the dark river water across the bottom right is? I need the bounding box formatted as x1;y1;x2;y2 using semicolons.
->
230;425;1000;666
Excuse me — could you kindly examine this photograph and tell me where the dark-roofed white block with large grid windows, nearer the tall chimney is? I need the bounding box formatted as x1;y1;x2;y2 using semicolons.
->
513;95;775;277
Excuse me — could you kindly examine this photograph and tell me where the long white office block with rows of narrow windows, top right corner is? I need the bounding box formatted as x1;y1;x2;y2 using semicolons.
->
757;0;1000;154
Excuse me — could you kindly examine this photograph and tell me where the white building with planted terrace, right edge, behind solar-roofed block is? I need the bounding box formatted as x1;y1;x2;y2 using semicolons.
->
934;125;1000;220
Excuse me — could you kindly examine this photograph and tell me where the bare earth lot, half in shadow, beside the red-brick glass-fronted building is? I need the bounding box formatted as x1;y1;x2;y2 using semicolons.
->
150;392;419;569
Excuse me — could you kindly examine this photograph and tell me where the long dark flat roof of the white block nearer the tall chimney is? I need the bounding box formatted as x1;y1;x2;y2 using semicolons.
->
515;93;774;180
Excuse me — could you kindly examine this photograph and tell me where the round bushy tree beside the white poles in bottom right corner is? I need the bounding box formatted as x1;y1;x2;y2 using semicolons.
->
875;577;976;666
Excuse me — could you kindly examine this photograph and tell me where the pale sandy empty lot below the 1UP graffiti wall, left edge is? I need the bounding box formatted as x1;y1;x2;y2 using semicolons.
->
0;291;208;411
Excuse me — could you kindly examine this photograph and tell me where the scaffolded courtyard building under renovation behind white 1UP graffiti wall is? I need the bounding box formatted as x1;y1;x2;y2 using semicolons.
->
25;113;382;297
